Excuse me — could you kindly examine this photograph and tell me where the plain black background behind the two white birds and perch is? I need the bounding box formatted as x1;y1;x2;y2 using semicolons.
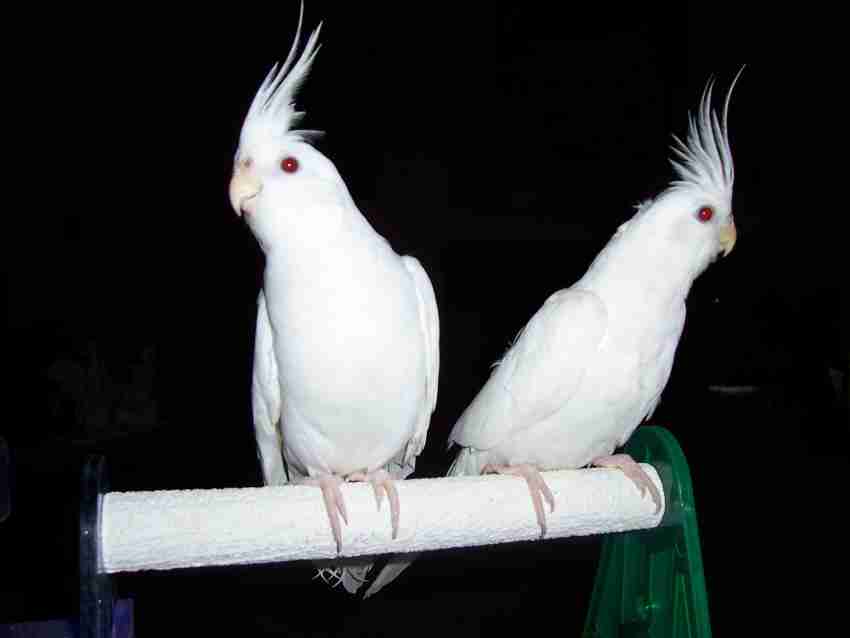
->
0;1;850;636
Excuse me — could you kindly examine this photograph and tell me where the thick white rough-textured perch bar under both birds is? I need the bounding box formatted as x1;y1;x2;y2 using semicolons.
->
101;464;664;572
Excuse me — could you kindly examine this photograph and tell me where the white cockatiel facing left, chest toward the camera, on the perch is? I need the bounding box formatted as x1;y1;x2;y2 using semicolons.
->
225;6;439;591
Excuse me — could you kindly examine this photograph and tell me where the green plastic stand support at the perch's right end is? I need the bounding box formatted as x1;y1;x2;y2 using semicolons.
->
583;426;711;638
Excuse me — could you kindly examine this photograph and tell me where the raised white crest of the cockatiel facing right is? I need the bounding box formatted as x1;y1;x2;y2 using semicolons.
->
671;67;745;196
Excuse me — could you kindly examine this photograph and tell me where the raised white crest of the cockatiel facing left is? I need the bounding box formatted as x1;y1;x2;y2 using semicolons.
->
241;3;322;143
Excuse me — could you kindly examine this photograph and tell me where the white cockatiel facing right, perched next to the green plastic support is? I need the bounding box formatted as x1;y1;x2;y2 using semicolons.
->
449;69;743;535
